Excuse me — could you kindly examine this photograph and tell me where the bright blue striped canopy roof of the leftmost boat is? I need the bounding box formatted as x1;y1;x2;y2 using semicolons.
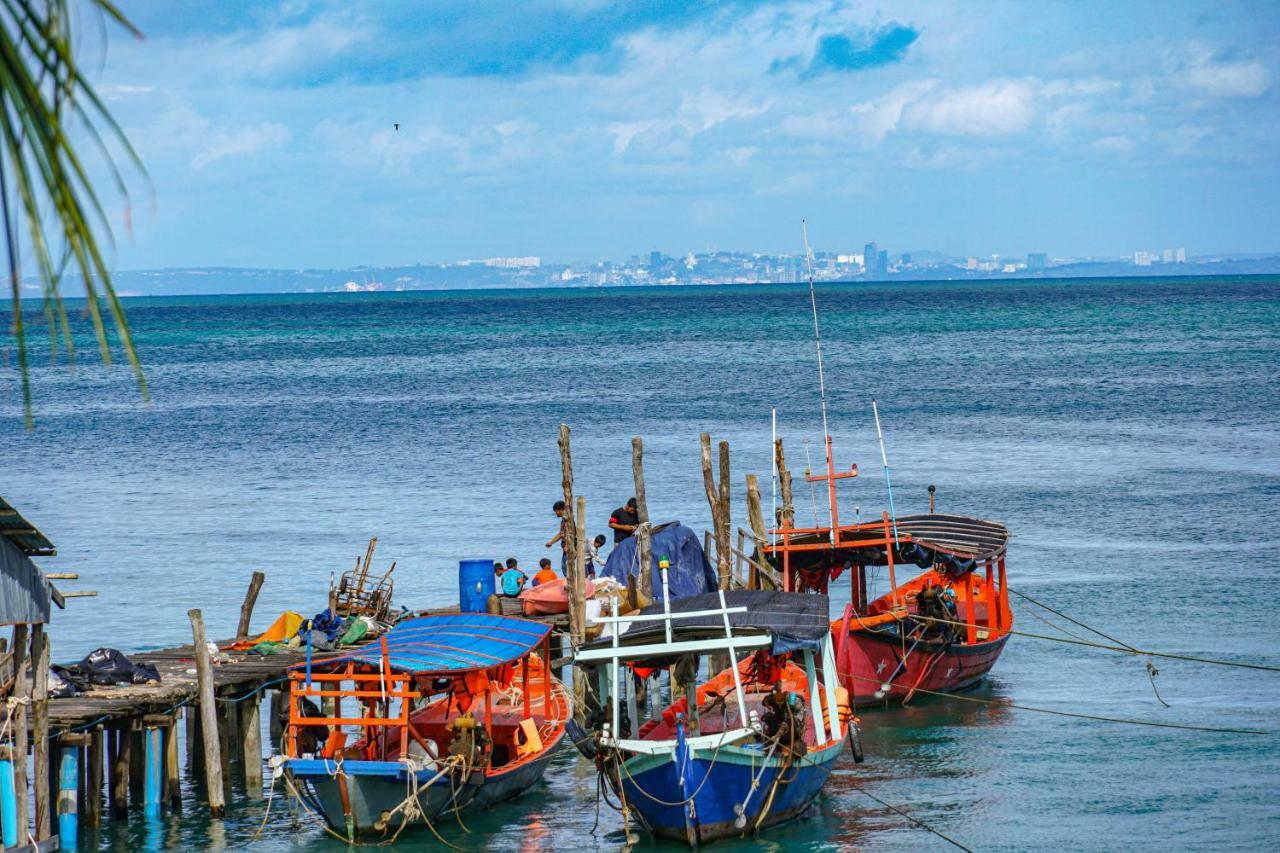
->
309;613;552;675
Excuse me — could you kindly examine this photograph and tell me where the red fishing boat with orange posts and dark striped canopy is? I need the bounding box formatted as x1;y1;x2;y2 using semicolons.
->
763;437;1014;707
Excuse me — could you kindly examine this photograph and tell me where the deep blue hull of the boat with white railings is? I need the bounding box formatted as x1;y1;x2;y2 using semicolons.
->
611;740;844;845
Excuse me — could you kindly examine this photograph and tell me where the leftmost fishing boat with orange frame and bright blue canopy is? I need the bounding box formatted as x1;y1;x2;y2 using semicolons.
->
283;613;571;841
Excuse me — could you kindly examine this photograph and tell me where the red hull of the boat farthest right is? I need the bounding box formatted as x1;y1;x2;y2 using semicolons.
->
836;622;1009;707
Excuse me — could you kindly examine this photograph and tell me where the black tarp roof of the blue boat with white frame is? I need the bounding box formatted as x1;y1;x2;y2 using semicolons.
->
584;589;831;654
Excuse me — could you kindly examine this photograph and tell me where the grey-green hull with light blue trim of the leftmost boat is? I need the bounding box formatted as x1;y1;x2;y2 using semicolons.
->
285;733;563;835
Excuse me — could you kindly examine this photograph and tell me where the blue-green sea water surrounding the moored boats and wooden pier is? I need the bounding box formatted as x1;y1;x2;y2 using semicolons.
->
0;278;1280;850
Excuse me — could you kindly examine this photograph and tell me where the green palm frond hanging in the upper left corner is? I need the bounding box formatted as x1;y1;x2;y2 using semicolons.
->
0;0;148;429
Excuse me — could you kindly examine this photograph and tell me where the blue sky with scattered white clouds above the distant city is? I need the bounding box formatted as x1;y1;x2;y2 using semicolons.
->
86;0;1280;269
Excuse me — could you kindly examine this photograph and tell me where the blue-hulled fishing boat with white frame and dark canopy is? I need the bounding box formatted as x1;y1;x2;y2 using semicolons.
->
575;581;860;847
